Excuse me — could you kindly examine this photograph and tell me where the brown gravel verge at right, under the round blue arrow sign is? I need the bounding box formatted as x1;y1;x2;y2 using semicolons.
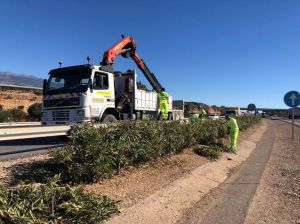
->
245;121;300;224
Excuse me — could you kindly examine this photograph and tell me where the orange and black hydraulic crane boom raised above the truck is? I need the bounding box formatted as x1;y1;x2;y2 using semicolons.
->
100;36;162;92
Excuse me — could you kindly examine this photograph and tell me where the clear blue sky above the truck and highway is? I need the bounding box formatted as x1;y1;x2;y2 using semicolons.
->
0;0;300;108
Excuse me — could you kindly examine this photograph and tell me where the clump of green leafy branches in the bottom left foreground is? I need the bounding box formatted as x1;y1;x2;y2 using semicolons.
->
0;176;118;224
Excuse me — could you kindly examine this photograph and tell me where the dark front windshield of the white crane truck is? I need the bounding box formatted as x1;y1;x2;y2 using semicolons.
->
45;69;91;94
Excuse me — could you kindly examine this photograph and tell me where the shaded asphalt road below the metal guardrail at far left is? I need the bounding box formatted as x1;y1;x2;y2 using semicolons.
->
0;136;66;160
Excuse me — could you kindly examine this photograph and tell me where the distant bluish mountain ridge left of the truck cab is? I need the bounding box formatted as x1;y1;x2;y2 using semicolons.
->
0;72;43;88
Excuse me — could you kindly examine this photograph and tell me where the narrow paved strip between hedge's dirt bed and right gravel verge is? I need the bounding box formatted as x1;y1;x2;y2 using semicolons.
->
178;120;275;224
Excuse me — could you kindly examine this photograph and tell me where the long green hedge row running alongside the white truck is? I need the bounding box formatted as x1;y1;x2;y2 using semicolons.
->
51;116;260;183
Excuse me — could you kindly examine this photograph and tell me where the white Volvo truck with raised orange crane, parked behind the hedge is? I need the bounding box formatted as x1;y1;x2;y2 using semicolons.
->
41;36;183;125
